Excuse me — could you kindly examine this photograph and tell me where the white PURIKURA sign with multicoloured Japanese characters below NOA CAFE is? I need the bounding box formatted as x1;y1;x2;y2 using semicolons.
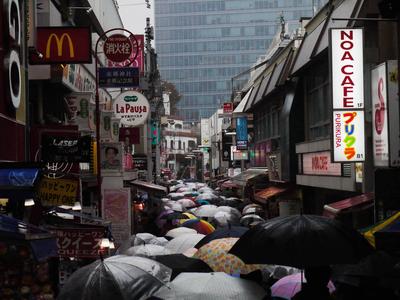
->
333;110;365;162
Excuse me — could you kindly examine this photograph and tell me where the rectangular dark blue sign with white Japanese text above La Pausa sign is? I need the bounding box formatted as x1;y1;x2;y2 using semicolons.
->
99;67;139;88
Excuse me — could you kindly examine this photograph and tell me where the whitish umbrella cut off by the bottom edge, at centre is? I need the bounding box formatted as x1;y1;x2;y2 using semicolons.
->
154;272;265;300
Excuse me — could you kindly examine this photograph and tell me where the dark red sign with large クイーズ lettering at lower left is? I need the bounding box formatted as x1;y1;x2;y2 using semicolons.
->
55;228;104;258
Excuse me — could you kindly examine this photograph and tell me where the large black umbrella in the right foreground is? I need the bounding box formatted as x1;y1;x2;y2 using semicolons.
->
230;215;373;268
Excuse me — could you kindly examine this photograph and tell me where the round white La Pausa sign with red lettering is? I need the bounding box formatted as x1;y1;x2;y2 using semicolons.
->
113;91;150;126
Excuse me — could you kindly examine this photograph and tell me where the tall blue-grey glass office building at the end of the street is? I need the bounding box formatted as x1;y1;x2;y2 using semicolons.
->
154;0;326;122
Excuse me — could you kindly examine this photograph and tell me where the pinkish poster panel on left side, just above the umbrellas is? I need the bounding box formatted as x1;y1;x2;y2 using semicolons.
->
102;188;131;248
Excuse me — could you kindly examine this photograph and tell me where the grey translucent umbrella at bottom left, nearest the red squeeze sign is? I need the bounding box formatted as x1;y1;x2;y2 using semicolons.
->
57;255;171;300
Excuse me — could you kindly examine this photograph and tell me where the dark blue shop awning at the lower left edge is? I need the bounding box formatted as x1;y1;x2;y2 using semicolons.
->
0;215;58;261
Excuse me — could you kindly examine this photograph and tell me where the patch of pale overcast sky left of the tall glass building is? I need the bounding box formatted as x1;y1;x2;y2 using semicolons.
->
118;0;154;34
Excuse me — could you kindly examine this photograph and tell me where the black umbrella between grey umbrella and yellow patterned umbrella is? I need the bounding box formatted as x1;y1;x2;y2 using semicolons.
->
152;254;213;280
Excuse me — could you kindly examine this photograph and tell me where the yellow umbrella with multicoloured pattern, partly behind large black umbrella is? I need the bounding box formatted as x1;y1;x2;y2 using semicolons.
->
193;238;262;274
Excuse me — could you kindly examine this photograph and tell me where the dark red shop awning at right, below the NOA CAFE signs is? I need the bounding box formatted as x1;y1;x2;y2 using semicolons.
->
324;193;375;218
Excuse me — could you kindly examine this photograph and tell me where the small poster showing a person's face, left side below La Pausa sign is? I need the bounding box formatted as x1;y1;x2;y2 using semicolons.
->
100;143;122;172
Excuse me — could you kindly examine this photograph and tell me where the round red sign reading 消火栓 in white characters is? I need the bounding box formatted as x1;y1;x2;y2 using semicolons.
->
103;34;133;62
